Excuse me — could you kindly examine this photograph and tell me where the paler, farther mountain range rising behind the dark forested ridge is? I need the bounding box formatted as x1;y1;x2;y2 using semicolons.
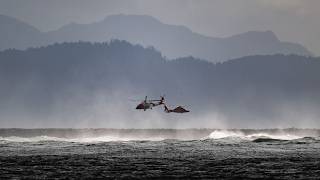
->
0;15;312;62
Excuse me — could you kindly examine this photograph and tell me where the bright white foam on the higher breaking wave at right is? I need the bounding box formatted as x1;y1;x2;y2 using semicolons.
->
205;130;303;140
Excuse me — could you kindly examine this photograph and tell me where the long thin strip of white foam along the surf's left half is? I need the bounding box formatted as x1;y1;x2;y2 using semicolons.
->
0;136;164;142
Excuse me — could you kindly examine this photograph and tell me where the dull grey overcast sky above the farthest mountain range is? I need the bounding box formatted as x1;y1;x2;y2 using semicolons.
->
0;0;320;55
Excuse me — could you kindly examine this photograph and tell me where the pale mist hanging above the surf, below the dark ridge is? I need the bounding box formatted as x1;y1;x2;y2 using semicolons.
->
1;86;318;129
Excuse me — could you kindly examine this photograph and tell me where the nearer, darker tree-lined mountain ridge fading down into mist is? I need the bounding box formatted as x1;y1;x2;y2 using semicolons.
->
0;40;320;127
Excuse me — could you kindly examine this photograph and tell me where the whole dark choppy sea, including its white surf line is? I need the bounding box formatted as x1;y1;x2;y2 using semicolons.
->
0;129;320;179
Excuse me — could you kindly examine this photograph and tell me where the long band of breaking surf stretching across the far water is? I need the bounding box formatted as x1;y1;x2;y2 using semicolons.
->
0;128;320;143
